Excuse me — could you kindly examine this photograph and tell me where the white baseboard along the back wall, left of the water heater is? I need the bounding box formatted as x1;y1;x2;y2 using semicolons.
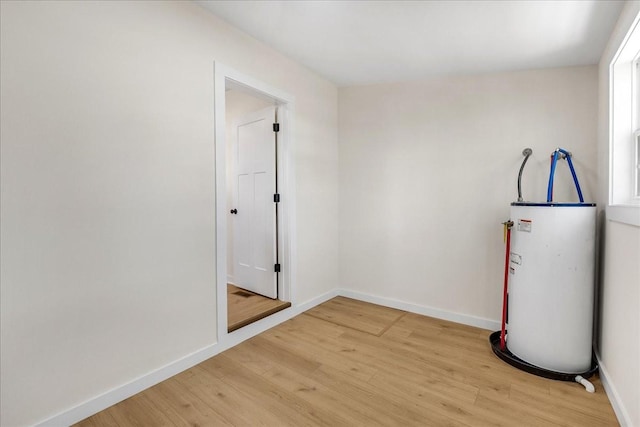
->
338;289;501;331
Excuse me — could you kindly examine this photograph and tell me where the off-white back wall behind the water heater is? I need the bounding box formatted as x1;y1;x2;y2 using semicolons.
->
339;66;598;324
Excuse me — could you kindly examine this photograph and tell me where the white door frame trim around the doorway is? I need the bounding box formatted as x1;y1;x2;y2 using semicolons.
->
214;62;296;343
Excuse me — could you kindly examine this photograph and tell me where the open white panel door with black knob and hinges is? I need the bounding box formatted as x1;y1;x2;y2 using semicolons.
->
231;107;277;298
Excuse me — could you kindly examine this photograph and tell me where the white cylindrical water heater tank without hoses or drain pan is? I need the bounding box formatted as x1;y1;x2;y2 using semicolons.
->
507;202;596;374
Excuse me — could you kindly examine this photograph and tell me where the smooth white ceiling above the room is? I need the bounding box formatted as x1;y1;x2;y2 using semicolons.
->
198;0;623;86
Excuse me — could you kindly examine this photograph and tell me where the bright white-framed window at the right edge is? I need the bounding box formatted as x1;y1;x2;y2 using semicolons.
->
607;10;640;227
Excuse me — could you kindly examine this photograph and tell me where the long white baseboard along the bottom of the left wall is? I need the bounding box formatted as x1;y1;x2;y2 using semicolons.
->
36;289;338;427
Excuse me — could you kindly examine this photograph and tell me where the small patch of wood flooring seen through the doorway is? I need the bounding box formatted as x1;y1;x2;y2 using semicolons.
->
227;284;291;332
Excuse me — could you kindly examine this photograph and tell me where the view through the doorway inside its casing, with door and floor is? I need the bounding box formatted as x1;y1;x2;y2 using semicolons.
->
225;96;291;332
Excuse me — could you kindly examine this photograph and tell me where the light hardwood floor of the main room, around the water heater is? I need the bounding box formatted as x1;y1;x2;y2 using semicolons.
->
79;297;618;427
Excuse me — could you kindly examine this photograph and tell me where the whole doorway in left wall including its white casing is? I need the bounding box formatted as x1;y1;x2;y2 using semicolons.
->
215;63;294;340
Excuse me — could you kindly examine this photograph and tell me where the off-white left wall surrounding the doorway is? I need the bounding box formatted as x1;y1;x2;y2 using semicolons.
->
0;1;338;426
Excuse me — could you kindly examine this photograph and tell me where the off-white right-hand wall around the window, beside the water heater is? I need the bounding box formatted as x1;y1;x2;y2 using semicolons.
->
597;1;640;426
